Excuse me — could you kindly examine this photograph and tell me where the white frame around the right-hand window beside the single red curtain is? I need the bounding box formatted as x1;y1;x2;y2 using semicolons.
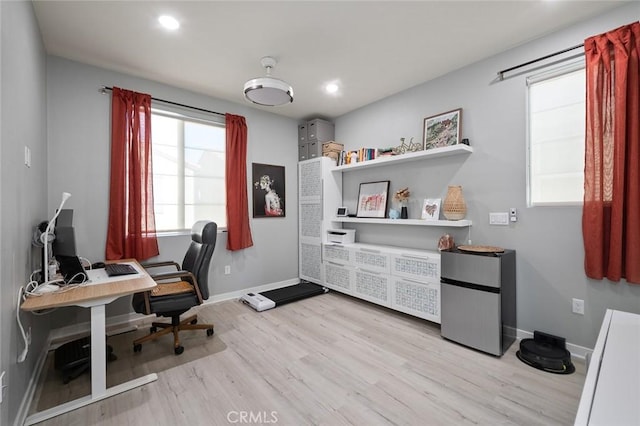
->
526;56;586;207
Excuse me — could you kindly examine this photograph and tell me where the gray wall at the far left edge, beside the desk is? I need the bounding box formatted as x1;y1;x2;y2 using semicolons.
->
0;1;49;424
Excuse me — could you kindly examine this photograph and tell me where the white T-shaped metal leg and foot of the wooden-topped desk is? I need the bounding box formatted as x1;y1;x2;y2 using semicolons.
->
24;305;158;425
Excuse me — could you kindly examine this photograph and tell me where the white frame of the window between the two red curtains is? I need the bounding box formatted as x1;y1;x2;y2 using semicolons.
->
151;104;227;233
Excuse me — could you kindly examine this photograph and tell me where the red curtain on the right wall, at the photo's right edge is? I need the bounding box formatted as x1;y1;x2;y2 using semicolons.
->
582;22;640;284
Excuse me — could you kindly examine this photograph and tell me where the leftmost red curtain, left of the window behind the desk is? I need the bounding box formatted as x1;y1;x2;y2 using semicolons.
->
106;87;159;260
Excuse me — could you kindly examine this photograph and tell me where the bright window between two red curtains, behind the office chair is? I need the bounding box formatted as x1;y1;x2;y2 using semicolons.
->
151;109;227;232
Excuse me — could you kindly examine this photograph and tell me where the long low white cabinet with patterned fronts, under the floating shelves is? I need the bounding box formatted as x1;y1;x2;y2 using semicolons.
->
322;243;440;323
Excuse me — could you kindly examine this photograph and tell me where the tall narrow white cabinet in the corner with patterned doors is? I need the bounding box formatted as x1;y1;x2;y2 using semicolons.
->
298;157;342;284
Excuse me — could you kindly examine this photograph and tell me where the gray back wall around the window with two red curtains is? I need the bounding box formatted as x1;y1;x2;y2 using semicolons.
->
47;56;298;326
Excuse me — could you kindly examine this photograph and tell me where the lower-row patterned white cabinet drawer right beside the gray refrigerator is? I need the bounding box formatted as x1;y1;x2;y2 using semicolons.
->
391;277;440;324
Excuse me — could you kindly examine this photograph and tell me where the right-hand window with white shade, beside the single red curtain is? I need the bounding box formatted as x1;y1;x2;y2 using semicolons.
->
527;60;586;206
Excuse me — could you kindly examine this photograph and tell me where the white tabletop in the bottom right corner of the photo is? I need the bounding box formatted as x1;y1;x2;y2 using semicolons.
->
574;309;640;426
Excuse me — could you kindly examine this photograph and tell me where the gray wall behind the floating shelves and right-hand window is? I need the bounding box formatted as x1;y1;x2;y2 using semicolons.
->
336;3;640;348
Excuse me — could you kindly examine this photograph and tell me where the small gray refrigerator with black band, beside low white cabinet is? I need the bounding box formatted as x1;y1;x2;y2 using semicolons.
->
440;248;517;356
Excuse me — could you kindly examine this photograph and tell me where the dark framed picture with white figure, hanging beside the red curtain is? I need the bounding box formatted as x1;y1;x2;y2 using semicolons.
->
252;163;285;217
